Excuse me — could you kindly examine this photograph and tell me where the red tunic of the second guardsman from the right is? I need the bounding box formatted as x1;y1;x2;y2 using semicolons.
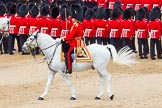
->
135;19;148;38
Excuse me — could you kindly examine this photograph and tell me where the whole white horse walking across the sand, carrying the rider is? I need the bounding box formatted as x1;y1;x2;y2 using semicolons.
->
22;32;137;100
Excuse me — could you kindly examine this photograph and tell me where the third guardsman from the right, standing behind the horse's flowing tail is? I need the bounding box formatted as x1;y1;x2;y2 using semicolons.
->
121;8;134;48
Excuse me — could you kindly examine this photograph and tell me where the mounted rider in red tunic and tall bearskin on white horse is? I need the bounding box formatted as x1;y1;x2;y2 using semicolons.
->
61;4;83;74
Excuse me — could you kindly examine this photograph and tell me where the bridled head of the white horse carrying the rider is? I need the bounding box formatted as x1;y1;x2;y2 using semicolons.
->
22;30;39;53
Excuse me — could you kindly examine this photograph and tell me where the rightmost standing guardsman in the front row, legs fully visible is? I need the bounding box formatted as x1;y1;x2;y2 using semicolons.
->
148;8;162;60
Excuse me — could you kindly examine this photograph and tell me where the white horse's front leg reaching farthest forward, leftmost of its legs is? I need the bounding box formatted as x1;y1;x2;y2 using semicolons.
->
38;70;56;100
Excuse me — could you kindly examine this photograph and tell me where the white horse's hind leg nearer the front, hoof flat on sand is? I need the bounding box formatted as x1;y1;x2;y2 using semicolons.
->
95;71;105;100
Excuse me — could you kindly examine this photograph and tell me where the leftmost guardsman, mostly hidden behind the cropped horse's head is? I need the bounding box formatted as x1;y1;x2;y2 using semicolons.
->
0;4;8;54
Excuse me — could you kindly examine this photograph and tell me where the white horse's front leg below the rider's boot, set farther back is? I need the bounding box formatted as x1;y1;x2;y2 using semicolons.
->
61;72;76;100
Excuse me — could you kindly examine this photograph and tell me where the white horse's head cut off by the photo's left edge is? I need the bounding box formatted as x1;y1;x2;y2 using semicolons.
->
0;18;10;37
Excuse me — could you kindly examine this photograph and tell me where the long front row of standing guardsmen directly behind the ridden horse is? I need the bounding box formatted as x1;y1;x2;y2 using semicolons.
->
0;3;162;60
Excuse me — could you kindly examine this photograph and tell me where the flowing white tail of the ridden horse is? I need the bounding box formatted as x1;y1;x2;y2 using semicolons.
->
107;45;138;66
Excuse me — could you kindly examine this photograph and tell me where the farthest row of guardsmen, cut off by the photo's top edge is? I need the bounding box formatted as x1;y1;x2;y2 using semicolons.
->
49;0;162;10
